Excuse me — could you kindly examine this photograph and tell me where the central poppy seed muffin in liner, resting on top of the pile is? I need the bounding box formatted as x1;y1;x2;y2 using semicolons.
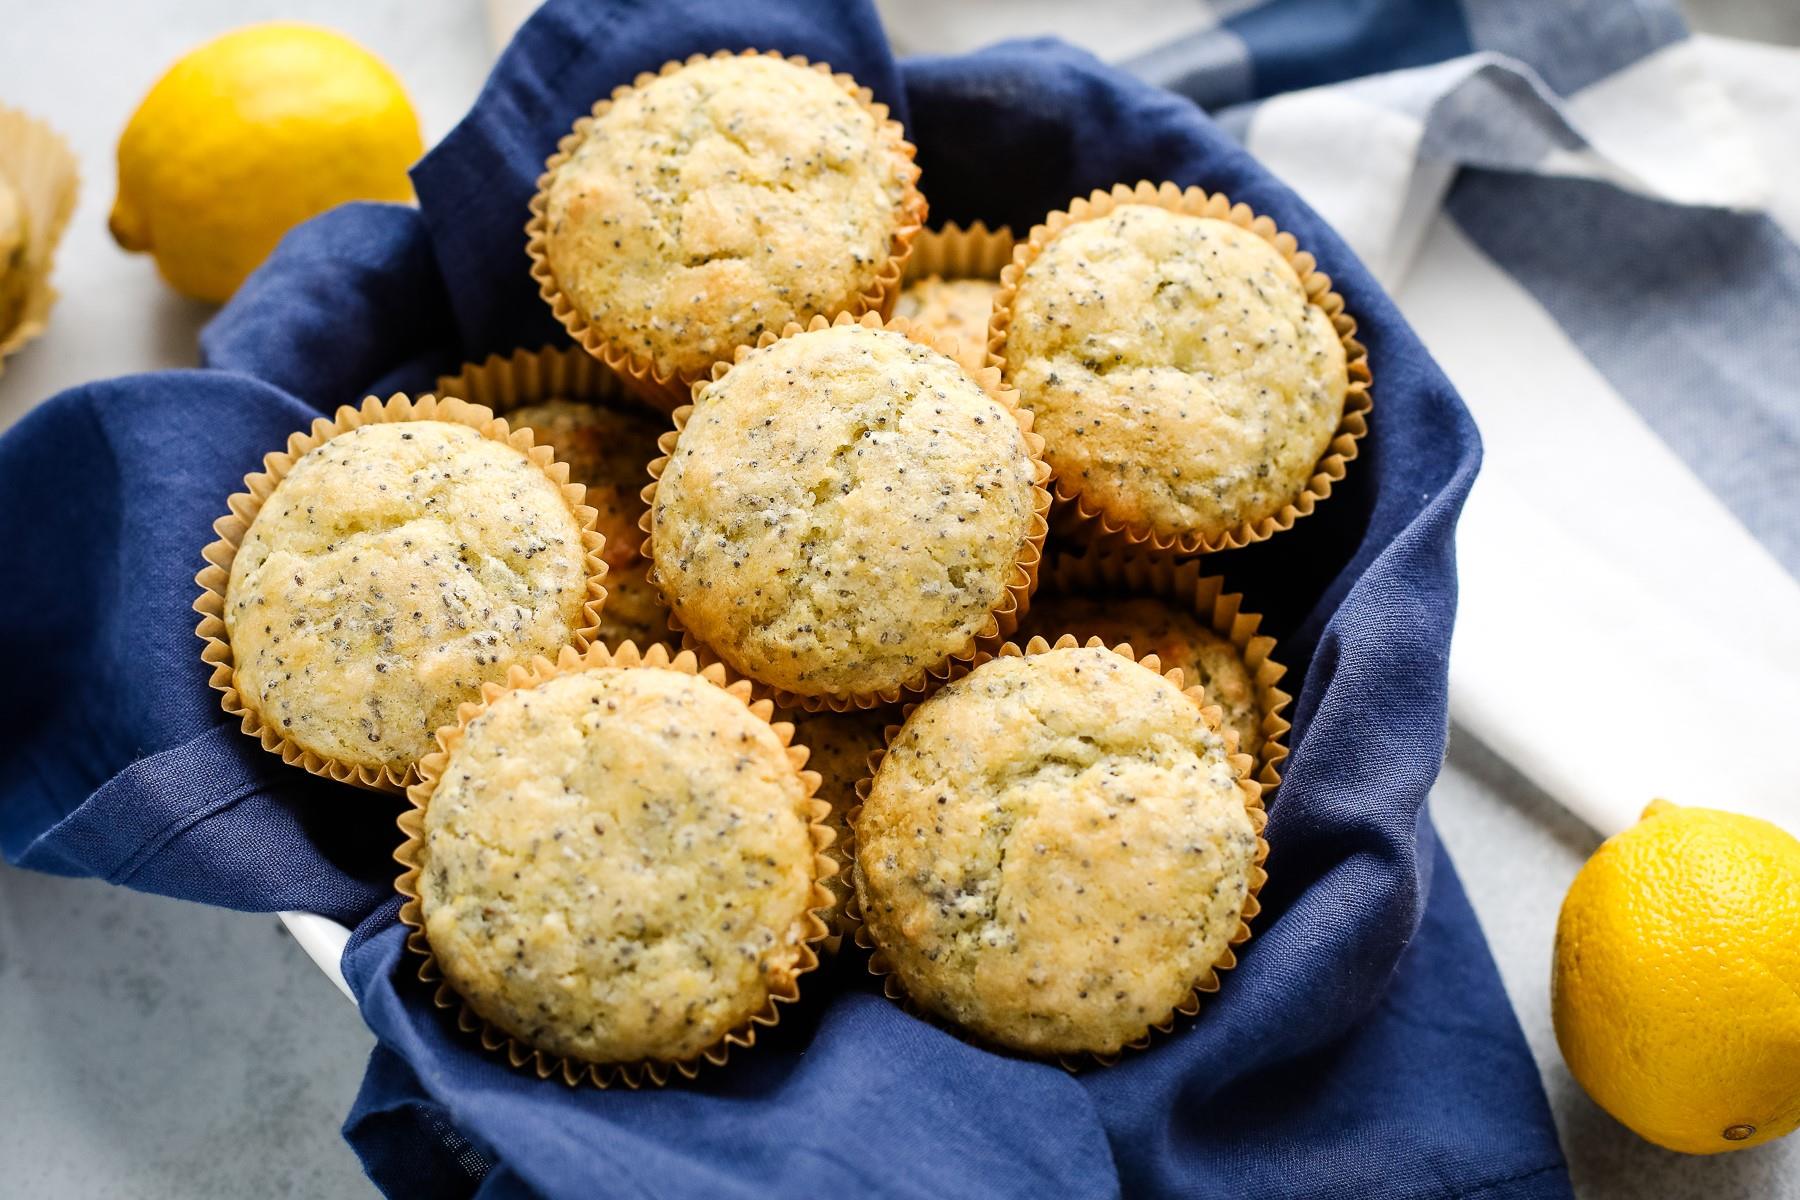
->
648;313;1049;709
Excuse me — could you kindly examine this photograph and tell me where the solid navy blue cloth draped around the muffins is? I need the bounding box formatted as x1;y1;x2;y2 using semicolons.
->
0;0;1568;1198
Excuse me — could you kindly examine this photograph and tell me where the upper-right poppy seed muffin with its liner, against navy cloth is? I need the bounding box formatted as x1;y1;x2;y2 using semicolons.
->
988;184;1370;554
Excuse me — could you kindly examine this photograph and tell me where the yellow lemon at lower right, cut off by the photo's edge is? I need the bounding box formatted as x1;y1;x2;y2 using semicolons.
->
1550;801;1800;1155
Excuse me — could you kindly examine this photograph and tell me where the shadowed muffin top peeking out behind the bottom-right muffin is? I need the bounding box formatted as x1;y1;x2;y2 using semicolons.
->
1019;592;1262;757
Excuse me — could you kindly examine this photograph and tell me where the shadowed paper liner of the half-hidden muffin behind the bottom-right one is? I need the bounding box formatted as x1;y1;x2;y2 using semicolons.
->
1040;551;1294;802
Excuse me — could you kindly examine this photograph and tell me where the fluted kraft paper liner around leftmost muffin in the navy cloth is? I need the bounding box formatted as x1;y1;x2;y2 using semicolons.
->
194;394;607;792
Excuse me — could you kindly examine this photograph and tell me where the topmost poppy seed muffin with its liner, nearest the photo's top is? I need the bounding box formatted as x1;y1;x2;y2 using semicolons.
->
526;50;925;407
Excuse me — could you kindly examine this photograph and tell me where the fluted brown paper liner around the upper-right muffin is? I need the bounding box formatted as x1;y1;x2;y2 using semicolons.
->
988;180;1372;554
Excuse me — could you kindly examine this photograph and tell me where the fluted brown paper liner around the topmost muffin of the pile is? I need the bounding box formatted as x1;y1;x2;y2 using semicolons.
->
526;50;925;412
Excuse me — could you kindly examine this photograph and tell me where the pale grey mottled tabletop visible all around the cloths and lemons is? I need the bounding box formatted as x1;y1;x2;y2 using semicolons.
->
0;0;1800;1200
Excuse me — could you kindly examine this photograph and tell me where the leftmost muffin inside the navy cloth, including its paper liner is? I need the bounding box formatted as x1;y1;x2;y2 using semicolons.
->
194;396;607;792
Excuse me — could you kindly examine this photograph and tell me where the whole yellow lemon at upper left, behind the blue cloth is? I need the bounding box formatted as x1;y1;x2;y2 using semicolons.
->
110;23;423;302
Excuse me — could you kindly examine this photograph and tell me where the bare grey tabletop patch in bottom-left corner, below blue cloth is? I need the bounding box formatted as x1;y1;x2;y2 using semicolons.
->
0;867;374;1200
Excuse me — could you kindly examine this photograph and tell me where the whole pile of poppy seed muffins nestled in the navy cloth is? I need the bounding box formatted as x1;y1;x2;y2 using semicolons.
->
196;49;1370;1088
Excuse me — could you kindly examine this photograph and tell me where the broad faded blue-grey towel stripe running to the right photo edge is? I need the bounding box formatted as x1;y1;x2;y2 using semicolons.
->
1447;171;1800;576
